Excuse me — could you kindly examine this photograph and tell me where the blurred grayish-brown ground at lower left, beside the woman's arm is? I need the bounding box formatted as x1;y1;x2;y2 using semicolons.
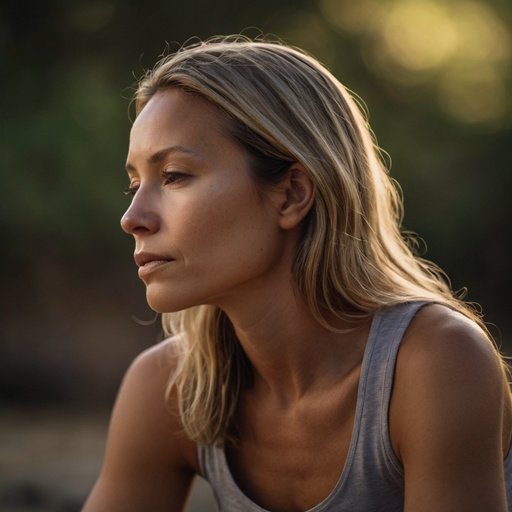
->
0;407;215;512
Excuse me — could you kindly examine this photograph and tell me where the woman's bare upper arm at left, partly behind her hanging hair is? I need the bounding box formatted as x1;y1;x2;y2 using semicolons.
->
83;342;195;512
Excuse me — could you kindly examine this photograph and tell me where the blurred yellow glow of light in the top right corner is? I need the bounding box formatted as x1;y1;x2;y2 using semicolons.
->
321;0;512;126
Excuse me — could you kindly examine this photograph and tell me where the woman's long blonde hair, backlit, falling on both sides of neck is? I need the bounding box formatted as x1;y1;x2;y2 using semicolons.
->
135;36;496;443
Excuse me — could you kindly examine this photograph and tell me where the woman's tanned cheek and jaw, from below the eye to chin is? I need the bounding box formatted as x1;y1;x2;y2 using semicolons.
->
147;190;284;311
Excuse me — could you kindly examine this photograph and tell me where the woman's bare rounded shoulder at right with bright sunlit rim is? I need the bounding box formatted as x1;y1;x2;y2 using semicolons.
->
395;304;510;420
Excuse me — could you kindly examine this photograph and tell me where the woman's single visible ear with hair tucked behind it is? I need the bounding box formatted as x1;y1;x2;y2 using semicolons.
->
278;163;315;230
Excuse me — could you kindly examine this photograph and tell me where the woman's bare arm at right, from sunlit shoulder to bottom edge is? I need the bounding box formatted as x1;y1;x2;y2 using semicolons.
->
390;306;510;512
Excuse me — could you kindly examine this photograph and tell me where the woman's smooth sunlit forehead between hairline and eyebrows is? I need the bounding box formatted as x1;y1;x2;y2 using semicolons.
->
130;88;231;153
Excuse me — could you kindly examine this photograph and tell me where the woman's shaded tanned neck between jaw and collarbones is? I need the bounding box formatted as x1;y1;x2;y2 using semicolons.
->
218;287;369;406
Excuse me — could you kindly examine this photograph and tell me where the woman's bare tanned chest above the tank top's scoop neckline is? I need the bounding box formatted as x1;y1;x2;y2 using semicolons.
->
226;372;359;512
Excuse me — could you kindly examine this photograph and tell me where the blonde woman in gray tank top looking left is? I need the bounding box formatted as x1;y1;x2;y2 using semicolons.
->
84;37;512;512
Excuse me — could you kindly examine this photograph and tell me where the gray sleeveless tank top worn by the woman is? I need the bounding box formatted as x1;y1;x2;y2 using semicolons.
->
198;302;512;512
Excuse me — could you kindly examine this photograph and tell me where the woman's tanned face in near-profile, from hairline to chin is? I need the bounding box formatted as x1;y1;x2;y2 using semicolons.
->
121;89;284;312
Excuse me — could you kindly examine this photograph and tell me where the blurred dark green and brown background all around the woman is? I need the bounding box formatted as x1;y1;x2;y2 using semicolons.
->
0;0;512;512
